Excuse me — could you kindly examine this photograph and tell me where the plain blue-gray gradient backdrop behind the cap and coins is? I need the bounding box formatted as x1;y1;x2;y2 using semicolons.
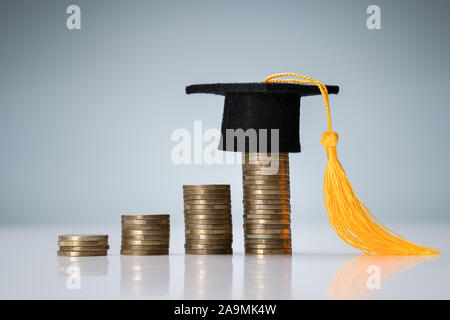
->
0;0;450;227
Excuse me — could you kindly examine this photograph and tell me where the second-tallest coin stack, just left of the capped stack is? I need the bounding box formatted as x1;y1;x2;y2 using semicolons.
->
183;185;233;254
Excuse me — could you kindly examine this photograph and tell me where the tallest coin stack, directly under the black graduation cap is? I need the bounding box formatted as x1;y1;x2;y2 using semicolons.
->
242;153;292;255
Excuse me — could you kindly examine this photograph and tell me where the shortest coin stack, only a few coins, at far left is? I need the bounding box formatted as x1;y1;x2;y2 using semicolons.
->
57;234;109;257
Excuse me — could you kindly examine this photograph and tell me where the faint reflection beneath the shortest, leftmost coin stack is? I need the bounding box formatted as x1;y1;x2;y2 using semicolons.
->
57;256;109;277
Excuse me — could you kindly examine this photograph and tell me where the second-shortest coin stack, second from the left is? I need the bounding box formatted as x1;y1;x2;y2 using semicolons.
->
120;214;170;256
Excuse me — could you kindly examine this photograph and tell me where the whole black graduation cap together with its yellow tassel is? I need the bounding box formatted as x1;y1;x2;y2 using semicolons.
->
186;73;439;255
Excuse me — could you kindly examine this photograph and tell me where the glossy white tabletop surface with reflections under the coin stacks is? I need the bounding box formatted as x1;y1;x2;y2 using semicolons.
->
0;224;450;299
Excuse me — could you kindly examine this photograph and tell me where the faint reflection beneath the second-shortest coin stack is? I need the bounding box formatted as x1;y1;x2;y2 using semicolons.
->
120;255;170;297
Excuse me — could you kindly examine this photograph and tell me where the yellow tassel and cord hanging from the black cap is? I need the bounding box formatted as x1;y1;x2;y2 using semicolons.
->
264;73;439;255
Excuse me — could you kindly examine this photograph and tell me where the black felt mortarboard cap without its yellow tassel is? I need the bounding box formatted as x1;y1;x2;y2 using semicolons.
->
186;83;339;152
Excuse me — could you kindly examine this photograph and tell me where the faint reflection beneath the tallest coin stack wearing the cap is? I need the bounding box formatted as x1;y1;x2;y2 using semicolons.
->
244;255;292;299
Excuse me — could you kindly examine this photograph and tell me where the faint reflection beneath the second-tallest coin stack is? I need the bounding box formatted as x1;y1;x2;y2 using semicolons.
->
184;255;233;299
